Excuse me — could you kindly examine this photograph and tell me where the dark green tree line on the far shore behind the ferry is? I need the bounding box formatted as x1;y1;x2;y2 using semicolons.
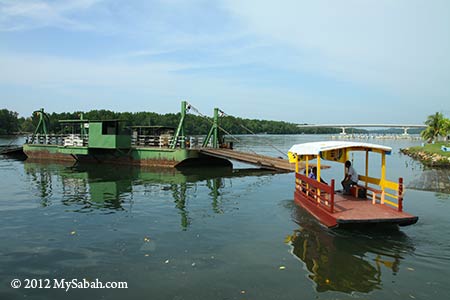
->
0;109;374;135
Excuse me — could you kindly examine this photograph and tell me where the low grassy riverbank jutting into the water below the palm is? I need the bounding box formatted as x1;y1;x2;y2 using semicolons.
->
400;142;450;168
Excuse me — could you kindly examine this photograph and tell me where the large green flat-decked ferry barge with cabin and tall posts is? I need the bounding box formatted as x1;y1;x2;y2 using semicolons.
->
23;101;231;167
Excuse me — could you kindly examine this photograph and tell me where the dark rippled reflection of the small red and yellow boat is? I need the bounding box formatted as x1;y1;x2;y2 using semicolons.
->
286;208;414;293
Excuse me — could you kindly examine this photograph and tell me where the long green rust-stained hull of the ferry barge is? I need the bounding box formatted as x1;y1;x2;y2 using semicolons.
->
23;144;231;168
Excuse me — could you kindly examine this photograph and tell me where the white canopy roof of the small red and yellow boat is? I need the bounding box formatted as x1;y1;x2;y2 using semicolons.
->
289;141;392;155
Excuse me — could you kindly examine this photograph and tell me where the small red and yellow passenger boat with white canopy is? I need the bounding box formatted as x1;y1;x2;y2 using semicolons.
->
288;141;418;228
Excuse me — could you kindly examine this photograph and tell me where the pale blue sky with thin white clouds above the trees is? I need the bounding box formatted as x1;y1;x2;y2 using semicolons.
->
0;0;450;124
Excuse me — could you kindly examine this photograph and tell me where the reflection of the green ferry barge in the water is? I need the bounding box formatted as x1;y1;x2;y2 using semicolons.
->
24;161;273;229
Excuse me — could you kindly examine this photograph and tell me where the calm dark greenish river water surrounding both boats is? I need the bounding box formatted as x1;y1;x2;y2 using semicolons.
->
0;135;450;300
